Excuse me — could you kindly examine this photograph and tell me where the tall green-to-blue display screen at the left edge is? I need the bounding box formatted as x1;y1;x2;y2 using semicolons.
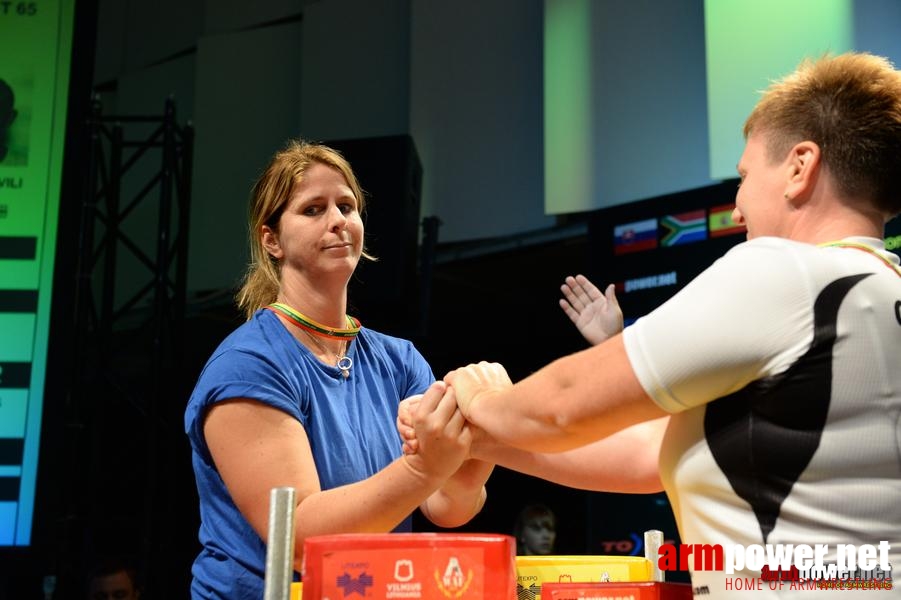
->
0;0;74;546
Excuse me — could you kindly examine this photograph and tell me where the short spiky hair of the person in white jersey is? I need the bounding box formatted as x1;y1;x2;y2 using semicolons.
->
744;52;901;216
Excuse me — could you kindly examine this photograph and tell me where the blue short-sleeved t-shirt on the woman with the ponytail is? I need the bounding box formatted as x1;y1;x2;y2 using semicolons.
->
185;310;434;600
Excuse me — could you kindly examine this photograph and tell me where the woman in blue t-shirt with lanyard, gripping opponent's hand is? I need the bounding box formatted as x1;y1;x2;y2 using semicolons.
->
185;141;493;600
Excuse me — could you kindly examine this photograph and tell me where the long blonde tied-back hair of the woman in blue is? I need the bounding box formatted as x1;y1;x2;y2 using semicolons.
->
236;140;374;319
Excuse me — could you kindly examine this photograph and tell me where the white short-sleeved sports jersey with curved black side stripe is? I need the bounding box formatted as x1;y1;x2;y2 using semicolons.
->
623;238;901;599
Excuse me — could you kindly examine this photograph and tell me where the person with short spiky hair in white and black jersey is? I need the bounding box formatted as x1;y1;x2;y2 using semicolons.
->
440;52;901;598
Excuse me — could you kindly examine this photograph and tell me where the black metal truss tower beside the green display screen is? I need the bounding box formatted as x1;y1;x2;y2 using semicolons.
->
60;97;194;597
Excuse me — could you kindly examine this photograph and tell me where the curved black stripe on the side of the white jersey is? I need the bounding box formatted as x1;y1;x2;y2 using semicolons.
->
704;273;872;543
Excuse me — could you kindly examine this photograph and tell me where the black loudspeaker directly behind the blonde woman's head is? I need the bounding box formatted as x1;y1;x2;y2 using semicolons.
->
323;135;422;335
